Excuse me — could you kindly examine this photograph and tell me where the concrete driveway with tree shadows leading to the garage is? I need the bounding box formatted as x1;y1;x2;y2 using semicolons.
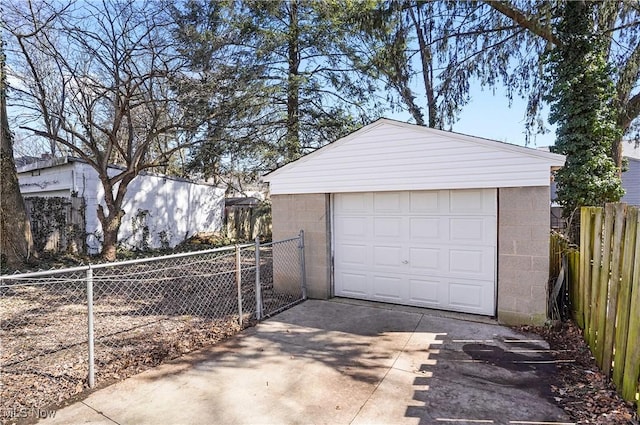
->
43;300;571;425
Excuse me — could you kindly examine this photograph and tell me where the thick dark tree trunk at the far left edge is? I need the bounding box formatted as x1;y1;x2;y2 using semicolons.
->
0;39;33;269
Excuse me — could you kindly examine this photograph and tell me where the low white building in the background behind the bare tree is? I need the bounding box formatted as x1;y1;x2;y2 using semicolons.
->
17;157;225;253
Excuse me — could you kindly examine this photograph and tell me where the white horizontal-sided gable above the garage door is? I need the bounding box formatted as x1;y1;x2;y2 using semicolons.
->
263;119;564;194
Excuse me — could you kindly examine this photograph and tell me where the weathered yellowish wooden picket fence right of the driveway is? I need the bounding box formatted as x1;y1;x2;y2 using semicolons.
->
566;204;640;410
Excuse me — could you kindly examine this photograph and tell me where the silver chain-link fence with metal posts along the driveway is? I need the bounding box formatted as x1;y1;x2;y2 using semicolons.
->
0;232;306;422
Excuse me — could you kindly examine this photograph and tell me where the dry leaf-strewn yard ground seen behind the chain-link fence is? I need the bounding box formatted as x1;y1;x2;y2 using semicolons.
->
0;248;300;423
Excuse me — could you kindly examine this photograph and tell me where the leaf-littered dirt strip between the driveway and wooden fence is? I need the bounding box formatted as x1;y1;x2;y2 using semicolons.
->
518;322;640;425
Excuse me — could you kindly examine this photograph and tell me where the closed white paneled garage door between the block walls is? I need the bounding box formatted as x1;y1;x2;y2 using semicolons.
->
333;189;497;315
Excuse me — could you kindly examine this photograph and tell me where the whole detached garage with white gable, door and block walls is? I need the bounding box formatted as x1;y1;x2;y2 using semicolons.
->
265;119;564;323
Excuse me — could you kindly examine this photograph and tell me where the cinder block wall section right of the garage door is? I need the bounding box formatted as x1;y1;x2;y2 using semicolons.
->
498;186;550;325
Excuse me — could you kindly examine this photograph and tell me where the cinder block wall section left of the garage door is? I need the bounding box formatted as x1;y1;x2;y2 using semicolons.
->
271;193;331;299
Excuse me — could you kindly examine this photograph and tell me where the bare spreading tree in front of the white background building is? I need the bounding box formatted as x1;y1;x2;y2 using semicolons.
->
5;0;198;260
